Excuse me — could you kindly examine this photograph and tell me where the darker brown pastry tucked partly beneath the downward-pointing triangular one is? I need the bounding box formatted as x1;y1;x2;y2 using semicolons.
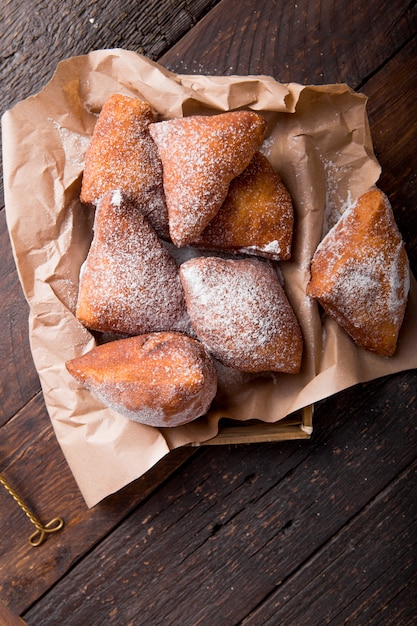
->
193;152;294;261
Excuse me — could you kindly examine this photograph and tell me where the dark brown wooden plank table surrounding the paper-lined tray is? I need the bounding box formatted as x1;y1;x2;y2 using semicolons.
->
0;0;417;626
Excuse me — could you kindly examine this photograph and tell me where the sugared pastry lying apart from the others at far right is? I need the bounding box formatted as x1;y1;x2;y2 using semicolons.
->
307;189;410;356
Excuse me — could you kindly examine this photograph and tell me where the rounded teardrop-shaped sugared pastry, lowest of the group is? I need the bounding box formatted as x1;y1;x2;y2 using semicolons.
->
66;332;217;427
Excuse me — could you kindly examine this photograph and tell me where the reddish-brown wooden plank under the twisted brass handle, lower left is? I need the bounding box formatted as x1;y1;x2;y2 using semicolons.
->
0;393;196;613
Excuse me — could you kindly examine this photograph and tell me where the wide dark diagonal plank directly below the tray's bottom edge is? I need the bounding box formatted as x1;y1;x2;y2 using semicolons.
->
23;372;417;626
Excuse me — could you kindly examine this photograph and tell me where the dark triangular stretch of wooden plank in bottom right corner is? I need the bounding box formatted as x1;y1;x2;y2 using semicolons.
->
242;462;417;626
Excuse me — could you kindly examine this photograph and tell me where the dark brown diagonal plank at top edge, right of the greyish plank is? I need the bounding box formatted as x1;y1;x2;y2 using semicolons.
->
162;0;417;88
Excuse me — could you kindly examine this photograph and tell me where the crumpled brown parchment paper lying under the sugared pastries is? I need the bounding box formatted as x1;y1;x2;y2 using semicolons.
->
2;50;417;506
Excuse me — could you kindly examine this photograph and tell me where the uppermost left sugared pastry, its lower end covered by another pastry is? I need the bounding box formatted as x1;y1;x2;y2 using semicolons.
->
80;94;169;238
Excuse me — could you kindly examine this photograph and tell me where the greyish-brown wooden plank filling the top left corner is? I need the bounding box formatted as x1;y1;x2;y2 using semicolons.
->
0;0;218;108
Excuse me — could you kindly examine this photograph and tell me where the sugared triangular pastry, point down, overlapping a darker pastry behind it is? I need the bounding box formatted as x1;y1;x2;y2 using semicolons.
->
150;111;266;247
